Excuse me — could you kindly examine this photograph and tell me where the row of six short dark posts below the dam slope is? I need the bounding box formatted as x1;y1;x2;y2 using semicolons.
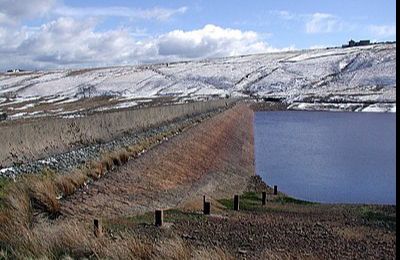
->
94;185;278;234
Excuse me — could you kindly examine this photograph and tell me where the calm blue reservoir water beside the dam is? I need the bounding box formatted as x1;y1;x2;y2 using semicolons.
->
254;111;396;204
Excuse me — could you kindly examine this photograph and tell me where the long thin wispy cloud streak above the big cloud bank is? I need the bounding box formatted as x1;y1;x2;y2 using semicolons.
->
54;6;187;21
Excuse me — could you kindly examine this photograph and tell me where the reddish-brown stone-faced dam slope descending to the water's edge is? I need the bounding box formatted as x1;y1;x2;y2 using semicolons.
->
62;105;254;218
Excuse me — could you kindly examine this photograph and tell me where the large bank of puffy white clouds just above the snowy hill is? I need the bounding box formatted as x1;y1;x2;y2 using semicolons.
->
0;17;294;70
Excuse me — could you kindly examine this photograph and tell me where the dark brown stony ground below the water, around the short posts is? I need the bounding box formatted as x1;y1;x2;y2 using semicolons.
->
106;176;396;259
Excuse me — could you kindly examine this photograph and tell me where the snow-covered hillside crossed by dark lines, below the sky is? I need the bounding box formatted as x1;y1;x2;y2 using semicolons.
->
0;44;396;119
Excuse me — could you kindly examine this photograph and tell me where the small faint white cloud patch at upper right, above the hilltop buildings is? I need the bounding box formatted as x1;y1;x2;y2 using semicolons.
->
306;13;343;34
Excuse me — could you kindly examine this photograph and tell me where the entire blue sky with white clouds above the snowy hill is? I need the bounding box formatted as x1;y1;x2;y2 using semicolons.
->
0;0;396;70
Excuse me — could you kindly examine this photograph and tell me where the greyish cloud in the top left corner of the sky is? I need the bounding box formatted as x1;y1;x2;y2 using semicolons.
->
0;0;55;25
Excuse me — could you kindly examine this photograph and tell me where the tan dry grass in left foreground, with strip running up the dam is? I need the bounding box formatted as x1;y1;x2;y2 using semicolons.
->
0;107;236;259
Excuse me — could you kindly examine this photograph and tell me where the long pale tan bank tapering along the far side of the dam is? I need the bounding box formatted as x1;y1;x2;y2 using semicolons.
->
0;100;232;168
